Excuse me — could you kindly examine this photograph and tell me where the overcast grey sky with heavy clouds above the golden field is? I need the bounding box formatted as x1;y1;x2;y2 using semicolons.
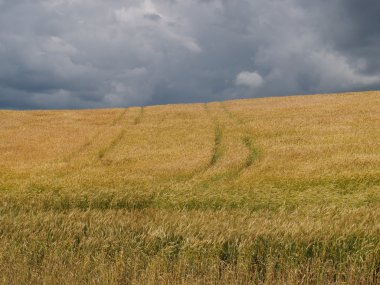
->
0;0;380;109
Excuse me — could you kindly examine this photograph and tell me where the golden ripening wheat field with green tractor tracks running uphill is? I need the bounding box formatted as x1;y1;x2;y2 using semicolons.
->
0;91;380;284
